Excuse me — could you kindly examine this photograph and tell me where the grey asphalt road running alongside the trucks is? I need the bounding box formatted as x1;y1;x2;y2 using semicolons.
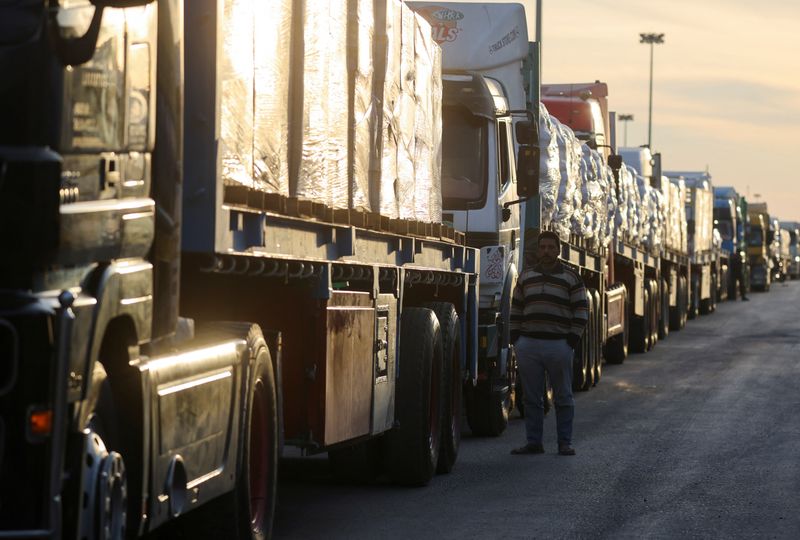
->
275;282;800;540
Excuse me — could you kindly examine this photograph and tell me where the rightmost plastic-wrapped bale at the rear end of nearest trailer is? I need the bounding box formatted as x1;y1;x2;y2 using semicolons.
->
413;14;441;221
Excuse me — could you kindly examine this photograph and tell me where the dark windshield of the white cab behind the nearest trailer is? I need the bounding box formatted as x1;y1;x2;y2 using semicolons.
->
442;107;489;210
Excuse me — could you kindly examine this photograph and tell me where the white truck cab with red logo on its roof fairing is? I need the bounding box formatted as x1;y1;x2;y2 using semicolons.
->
409;2;528;435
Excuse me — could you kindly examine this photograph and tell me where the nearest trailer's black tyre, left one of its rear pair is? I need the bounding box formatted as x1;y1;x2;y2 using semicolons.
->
386;308;444;486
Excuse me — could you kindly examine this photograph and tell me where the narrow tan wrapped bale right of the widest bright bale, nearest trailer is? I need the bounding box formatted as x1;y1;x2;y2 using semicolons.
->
348;0;378;211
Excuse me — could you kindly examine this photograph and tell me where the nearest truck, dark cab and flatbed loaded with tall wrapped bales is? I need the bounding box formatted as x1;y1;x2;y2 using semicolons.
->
0;0;482;539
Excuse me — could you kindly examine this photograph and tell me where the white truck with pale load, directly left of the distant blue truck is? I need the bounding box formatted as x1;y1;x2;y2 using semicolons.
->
665;171;729;319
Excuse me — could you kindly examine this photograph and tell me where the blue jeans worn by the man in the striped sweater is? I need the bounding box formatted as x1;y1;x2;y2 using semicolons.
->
515;336;575;445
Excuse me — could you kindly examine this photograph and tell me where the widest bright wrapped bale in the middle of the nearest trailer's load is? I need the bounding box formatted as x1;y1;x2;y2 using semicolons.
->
293;0;350;208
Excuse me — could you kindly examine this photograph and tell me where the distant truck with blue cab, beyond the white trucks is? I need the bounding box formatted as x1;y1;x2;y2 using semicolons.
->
714;186;750;300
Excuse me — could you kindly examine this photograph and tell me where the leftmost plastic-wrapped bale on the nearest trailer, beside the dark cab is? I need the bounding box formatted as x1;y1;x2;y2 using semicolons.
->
219;0;255;191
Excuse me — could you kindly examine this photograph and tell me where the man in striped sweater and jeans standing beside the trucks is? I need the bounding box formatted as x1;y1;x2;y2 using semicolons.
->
510;231;589;456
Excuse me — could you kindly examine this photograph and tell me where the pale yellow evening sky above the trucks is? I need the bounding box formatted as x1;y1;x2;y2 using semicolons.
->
482;0;800;221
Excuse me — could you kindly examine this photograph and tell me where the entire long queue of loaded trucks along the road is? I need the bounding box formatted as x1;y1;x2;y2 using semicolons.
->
0;0;800;539
